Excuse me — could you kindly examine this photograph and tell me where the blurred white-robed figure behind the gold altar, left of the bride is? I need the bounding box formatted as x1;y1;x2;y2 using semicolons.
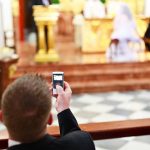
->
84;0;105;18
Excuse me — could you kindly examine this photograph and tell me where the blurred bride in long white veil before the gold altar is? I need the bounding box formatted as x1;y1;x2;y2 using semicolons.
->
106;2;141;62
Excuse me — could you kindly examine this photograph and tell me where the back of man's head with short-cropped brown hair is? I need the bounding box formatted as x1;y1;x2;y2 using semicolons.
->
1;74;51;142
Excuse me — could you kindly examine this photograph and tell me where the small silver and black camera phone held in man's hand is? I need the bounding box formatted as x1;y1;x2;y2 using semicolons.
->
52;72;64;95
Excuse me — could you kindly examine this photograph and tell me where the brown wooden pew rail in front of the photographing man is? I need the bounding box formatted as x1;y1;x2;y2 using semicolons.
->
0;119;150;149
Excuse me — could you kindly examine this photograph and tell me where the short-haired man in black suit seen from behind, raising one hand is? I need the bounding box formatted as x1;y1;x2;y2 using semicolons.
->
1;74;95;150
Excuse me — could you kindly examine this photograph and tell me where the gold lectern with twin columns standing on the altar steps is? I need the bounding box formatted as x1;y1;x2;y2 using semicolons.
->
33;5;59;63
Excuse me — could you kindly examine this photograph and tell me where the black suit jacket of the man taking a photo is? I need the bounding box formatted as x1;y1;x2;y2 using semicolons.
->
8;109;95;150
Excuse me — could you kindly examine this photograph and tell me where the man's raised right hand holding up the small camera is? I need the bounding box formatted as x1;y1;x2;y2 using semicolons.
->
55;81;72;113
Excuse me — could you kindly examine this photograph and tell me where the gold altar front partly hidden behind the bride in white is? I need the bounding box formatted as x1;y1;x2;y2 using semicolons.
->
82;17;149;53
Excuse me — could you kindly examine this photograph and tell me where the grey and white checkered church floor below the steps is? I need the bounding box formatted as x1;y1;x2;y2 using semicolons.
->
0;90;150;150
